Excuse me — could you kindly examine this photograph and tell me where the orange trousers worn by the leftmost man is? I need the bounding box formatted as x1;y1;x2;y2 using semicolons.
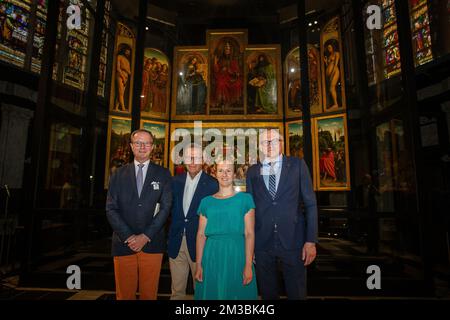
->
114;251;163;300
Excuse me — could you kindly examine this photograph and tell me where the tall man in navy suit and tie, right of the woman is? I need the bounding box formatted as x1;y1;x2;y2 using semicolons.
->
247;129;318;300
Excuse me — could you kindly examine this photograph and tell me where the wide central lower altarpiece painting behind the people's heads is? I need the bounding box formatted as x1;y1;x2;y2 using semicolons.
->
170;122;284;191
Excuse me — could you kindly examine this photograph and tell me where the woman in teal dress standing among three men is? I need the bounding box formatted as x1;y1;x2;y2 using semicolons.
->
194;161;258;300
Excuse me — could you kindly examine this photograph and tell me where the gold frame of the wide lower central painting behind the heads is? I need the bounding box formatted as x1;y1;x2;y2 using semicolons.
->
168;122;284;175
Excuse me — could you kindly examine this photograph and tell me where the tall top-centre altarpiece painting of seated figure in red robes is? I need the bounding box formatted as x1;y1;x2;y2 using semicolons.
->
207;30;247;115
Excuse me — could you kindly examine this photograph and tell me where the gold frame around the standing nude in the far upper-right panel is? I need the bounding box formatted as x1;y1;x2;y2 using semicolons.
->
320;16;347;113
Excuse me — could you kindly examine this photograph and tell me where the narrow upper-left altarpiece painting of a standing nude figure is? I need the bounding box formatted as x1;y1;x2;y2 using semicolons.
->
110;23;135;113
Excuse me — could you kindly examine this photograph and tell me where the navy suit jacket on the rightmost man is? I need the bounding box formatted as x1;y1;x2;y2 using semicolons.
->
247;155;318;251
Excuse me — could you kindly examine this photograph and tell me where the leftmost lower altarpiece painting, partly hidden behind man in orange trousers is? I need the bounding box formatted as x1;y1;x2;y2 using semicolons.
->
105;117;131;188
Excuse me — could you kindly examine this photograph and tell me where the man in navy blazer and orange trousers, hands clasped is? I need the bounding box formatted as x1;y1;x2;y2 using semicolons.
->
106;130;172;300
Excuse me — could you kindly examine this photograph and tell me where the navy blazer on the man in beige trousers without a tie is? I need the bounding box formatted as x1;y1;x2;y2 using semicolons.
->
169;172;219;261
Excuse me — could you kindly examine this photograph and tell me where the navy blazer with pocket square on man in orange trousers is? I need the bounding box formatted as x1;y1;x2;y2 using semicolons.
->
106;162;172;256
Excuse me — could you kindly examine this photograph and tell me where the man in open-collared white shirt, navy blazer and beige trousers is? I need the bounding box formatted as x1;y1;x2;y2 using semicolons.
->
169;144;219;300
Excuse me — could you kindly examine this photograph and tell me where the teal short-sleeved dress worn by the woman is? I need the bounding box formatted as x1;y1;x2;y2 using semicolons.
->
194;192;258;300
